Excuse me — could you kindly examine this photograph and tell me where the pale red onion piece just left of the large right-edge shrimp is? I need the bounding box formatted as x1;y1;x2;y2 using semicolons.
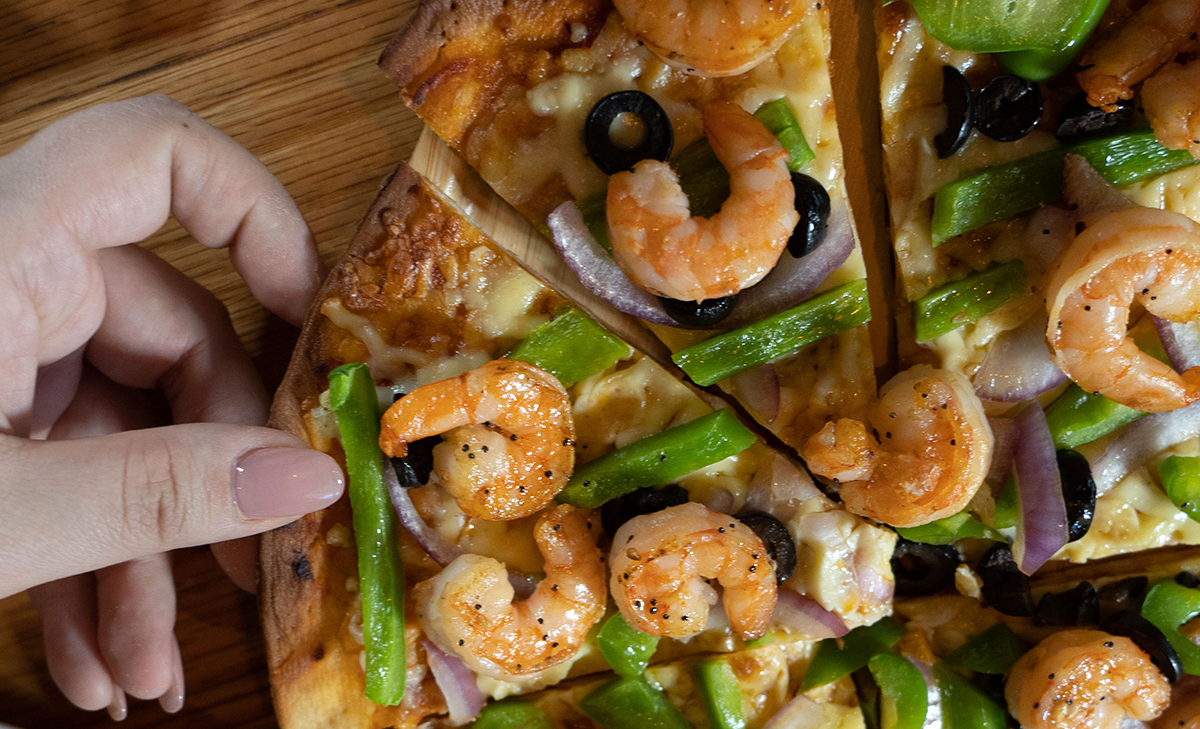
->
974;309;1067;403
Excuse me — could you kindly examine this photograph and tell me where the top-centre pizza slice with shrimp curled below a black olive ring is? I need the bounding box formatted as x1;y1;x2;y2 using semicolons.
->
380;0;875;455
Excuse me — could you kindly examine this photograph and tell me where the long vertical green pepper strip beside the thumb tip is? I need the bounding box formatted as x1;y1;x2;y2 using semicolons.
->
329;362;407;706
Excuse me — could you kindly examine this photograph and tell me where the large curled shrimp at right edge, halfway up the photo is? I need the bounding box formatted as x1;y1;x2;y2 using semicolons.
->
1046;207;1200;412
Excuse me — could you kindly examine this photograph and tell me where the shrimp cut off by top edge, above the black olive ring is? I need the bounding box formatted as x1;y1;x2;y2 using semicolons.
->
613;0;808;76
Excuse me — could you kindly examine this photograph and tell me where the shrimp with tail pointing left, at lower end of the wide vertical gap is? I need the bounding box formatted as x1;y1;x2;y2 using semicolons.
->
802;365;992;526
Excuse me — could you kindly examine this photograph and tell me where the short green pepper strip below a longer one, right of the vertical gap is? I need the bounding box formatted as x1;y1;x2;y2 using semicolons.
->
912;260;1025;342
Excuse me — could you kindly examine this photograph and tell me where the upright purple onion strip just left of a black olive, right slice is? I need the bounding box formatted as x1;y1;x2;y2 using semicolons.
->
1013;400;1067;574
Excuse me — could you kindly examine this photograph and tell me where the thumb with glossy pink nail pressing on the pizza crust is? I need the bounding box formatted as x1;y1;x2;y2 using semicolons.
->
0;423;344;597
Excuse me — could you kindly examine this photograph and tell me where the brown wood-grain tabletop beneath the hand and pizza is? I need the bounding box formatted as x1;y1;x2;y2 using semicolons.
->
0;0;888;729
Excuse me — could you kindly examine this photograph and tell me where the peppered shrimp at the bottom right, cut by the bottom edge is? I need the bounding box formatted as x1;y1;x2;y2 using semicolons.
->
1004;629;1171;729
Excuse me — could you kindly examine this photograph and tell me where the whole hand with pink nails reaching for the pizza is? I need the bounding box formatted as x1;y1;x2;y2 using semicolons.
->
0;97;343;718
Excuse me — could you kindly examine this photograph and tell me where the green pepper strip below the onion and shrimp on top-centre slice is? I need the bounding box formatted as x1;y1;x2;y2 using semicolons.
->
671;278;871;387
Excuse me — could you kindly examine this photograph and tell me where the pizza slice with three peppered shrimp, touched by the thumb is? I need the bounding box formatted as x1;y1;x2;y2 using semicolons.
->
262;167;895;729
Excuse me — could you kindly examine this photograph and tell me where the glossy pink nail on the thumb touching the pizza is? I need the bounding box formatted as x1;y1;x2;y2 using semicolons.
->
233;448;346;519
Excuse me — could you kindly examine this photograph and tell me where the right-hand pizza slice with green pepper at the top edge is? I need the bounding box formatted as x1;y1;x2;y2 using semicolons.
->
872;0;1200;572
